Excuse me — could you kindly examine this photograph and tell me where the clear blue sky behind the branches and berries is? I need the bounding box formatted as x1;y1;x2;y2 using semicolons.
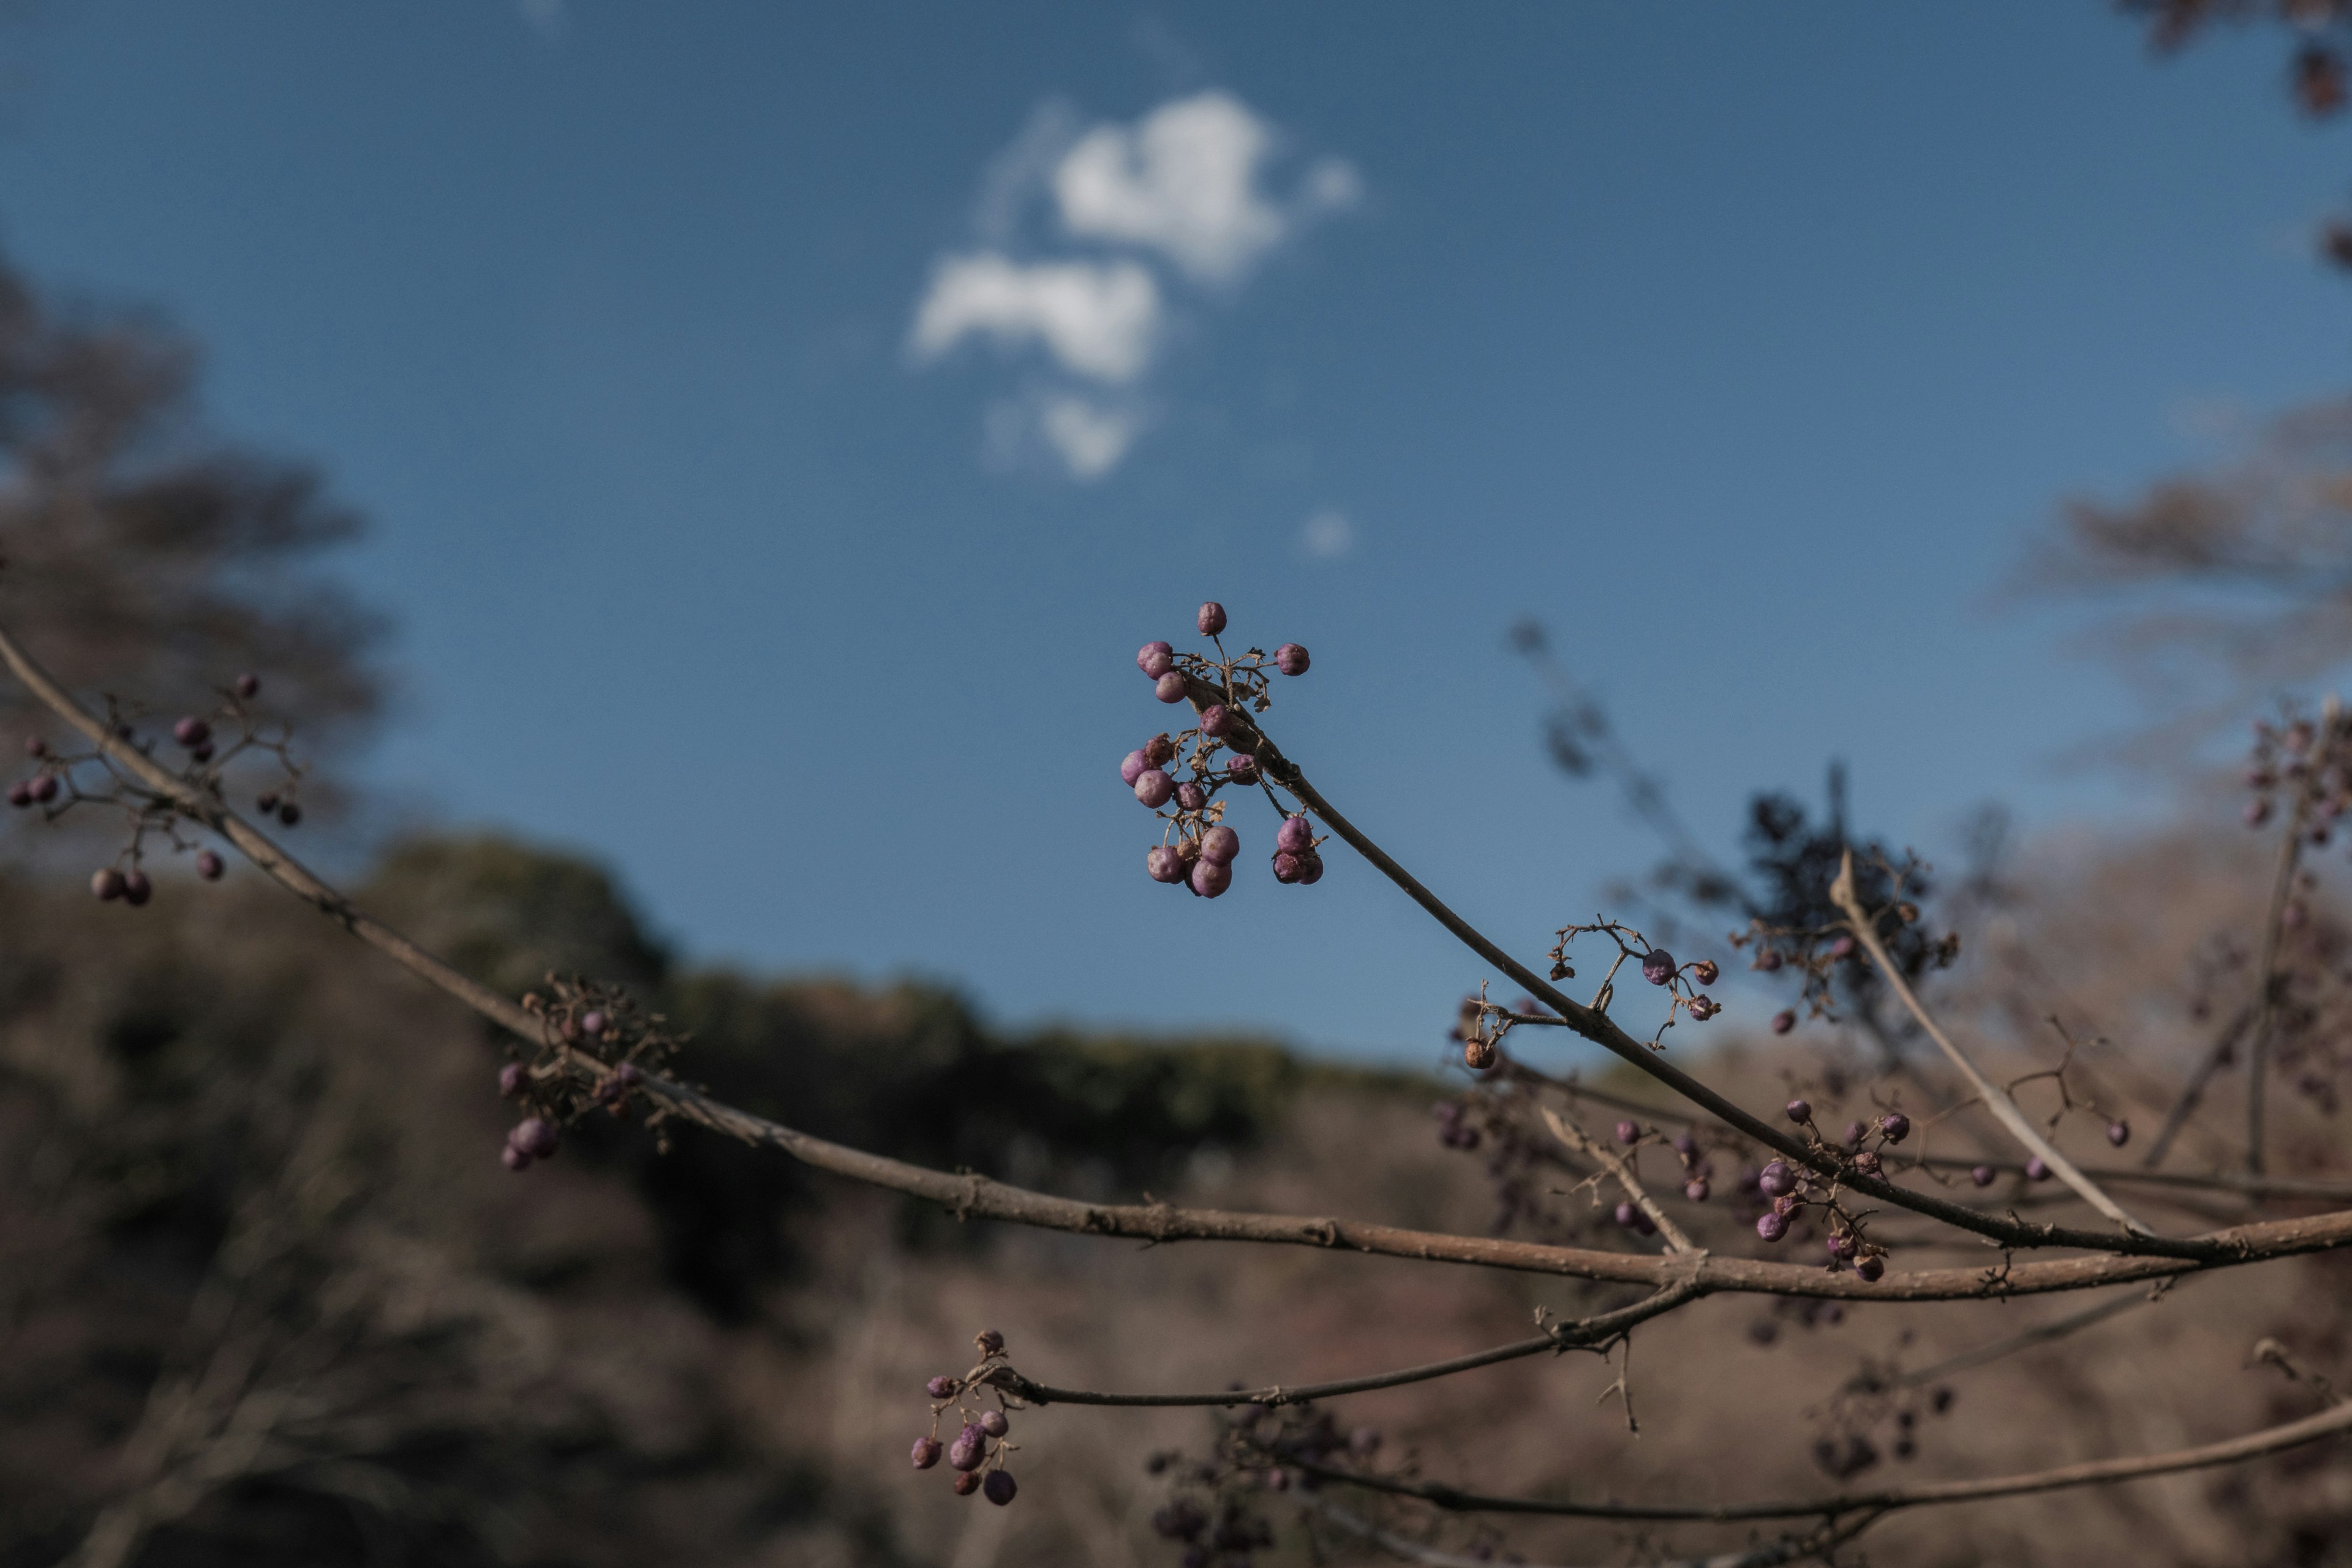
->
0;0;2352;1060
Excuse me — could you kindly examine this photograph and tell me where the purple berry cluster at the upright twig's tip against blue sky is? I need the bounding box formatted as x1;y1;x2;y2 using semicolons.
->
1120;602;1324;898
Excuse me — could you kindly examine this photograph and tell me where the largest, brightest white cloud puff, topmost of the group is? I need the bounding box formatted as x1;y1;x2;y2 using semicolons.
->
1054;92;1289;282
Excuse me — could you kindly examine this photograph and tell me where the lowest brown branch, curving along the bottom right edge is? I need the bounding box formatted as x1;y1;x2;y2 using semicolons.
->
1284;1403;2352;1523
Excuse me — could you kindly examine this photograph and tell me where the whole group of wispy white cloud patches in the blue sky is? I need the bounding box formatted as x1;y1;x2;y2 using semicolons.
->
908;92;1364;480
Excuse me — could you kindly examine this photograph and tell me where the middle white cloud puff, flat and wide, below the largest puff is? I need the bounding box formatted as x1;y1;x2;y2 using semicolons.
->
910;252;1159;383
